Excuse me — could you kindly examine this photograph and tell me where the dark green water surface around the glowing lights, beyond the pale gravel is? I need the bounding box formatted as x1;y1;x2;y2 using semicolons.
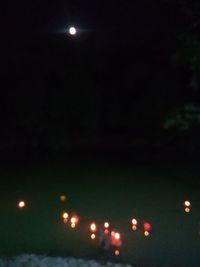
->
0;162;200;266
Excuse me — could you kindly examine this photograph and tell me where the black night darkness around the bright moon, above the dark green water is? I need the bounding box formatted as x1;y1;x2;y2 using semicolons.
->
1;0;199;161
